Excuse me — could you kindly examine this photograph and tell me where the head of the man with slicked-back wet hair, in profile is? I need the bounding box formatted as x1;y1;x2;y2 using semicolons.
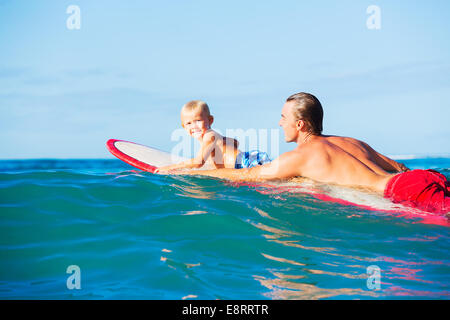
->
280;92;323;142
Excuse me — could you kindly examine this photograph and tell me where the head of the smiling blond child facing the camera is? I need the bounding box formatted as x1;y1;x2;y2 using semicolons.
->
181;100;214;139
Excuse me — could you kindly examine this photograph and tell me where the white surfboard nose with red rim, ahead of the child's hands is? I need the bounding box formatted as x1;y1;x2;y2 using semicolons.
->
106;139;186;173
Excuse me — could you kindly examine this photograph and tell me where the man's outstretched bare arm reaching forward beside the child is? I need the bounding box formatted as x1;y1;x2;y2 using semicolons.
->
169;151;301;181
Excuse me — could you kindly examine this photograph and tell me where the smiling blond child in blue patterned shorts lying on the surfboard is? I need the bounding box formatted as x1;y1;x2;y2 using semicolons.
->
156;100;270;173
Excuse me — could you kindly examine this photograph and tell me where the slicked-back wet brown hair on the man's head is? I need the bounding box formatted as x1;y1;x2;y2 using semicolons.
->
286;92;323;135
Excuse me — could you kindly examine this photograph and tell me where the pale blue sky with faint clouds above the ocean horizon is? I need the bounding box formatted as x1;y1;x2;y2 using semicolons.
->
0;0;450;159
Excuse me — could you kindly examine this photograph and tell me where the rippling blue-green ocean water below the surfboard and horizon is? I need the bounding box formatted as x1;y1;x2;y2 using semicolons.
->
0;158;450;299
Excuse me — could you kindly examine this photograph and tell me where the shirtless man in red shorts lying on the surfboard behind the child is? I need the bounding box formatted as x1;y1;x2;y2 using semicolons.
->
167;92;450;213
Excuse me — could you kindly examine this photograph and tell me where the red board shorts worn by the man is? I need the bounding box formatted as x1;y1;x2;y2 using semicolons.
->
384;169;450;214
